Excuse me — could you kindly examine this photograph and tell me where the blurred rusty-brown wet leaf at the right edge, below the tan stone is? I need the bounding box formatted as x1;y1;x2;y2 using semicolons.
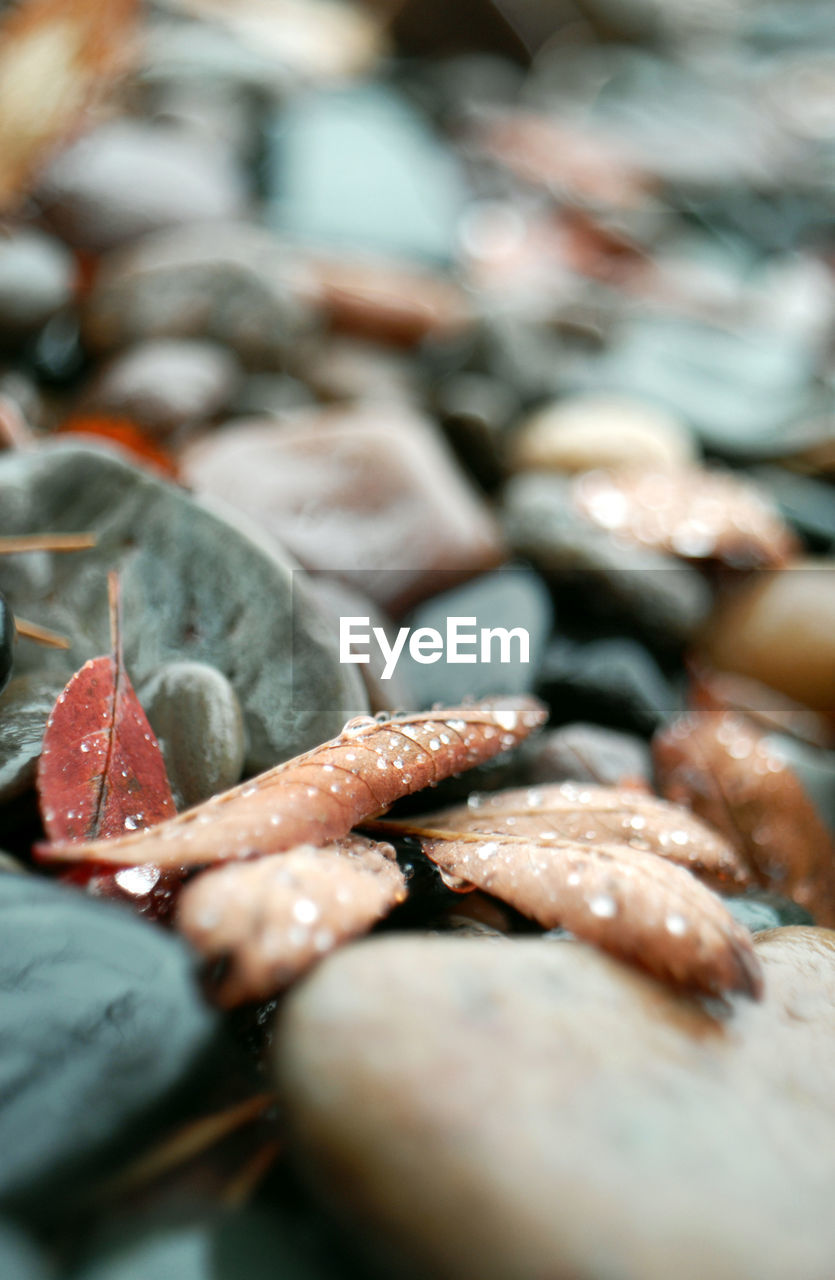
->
653;712;835;924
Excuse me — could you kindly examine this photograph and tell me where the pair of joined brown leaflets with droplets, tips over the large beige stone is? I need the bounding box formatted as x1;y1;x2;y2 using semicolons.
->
371;783;761;997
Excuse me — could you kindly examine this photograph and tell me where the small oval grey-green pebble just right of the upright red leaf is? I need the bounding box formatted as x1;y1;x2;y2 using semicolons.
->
138;662;246;809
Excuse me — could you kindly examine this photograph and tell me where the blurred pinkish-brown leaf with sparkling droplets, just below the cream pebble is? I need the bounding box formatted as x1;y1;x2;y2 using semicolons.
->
571;467;798;568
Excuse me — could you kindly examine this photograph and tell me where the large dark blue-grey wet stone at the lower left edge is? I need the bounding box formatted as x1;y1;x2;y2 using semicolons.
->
0;876;216;1208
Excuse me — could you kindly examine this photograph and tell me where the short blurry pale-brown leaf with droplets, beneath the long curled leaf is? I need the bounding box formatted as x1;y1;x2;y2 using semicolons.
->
177;836;406;1007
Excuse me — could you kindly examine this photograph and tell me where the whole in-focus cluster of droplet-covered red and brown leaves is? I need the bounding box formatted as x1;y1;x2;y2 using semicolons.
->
27;582;794;1006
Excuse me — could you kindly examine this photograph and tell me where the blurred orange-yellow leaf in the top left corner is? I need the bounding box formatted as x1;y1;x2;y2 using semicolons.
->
0;0;137;210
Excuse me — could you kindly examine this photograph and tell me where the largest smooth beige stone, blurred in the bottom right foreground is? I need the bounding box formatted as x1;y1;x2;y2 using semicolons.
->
275;928;835;1280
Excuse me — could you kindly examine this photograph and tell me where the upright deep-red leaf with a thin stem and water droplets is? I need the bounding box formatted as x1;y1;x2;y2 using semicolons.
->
37;577;175;844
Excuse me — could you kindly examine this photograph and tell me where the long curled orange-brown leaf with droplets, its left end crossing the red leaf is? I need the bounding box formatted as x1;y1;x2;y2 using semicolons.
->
38;696;547;868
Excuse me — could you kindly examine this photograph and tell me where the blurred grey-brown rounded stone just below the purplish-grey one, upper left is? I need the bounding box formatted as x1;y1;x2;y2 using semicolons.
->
82;223;311;369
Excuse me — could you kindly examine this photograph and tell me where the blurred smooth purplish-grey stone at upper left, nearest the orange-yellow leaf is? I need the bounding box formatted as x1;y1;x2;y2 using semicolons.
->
37;119;246;252
